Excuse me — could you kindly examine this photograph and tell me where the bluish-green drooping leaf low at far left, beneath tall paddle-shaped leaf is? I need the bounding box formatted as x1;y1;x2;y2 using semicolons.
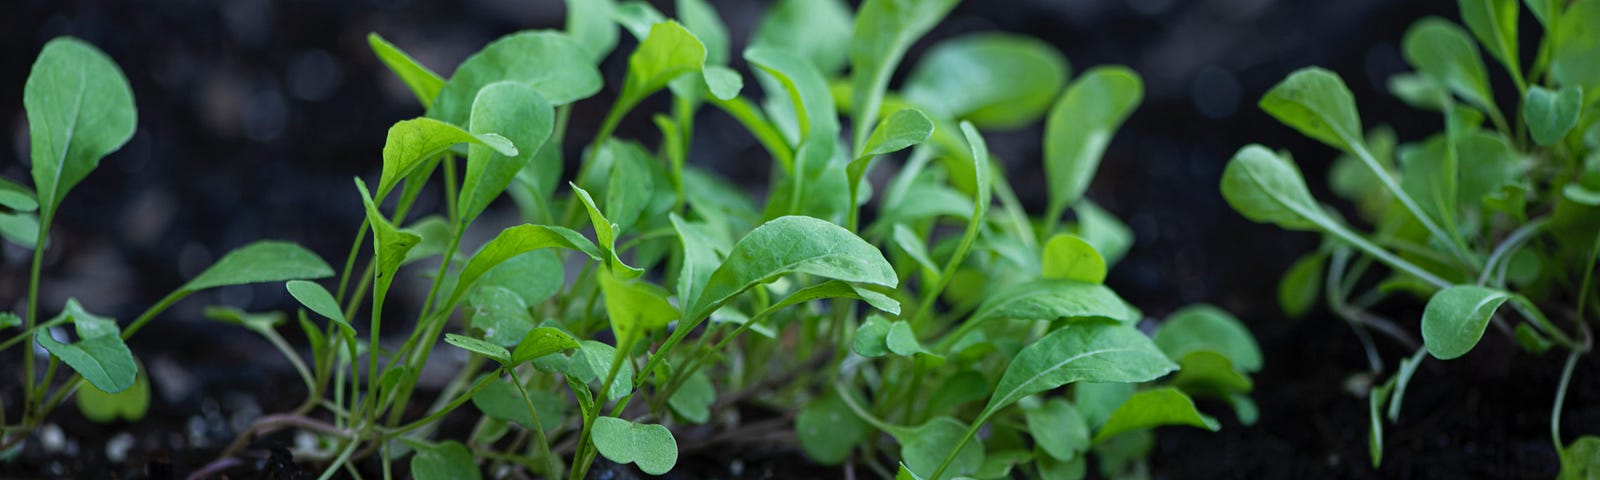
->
34;299;139;394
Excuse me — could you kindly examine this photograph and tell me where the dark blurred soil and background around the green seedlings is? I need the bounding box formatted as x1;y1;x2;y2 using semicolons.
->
0;0;1600;478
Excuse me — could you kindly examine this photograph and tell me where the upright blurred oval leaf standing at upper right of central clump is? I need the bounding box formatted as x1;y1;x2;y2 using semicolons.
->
1045;67;1144;213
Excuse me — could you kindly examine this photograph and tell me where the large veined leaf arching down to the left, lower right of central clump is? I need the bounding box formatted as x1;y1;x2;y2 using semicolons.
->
978;322;1178;422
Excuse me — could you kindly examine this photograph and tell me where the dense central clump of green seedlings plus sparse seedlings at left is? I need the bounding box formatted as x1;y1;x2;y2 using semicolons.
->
0;0;1273;478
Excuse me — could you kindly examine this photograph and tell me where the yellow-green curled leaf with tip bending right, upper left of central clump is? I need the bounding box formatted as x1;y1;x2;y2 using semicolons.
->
378;118;518;202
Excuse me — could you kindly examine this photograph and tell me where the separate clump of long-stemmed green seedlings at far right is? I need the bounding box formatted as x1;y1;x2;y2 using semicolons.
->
1228;0;1600;467
